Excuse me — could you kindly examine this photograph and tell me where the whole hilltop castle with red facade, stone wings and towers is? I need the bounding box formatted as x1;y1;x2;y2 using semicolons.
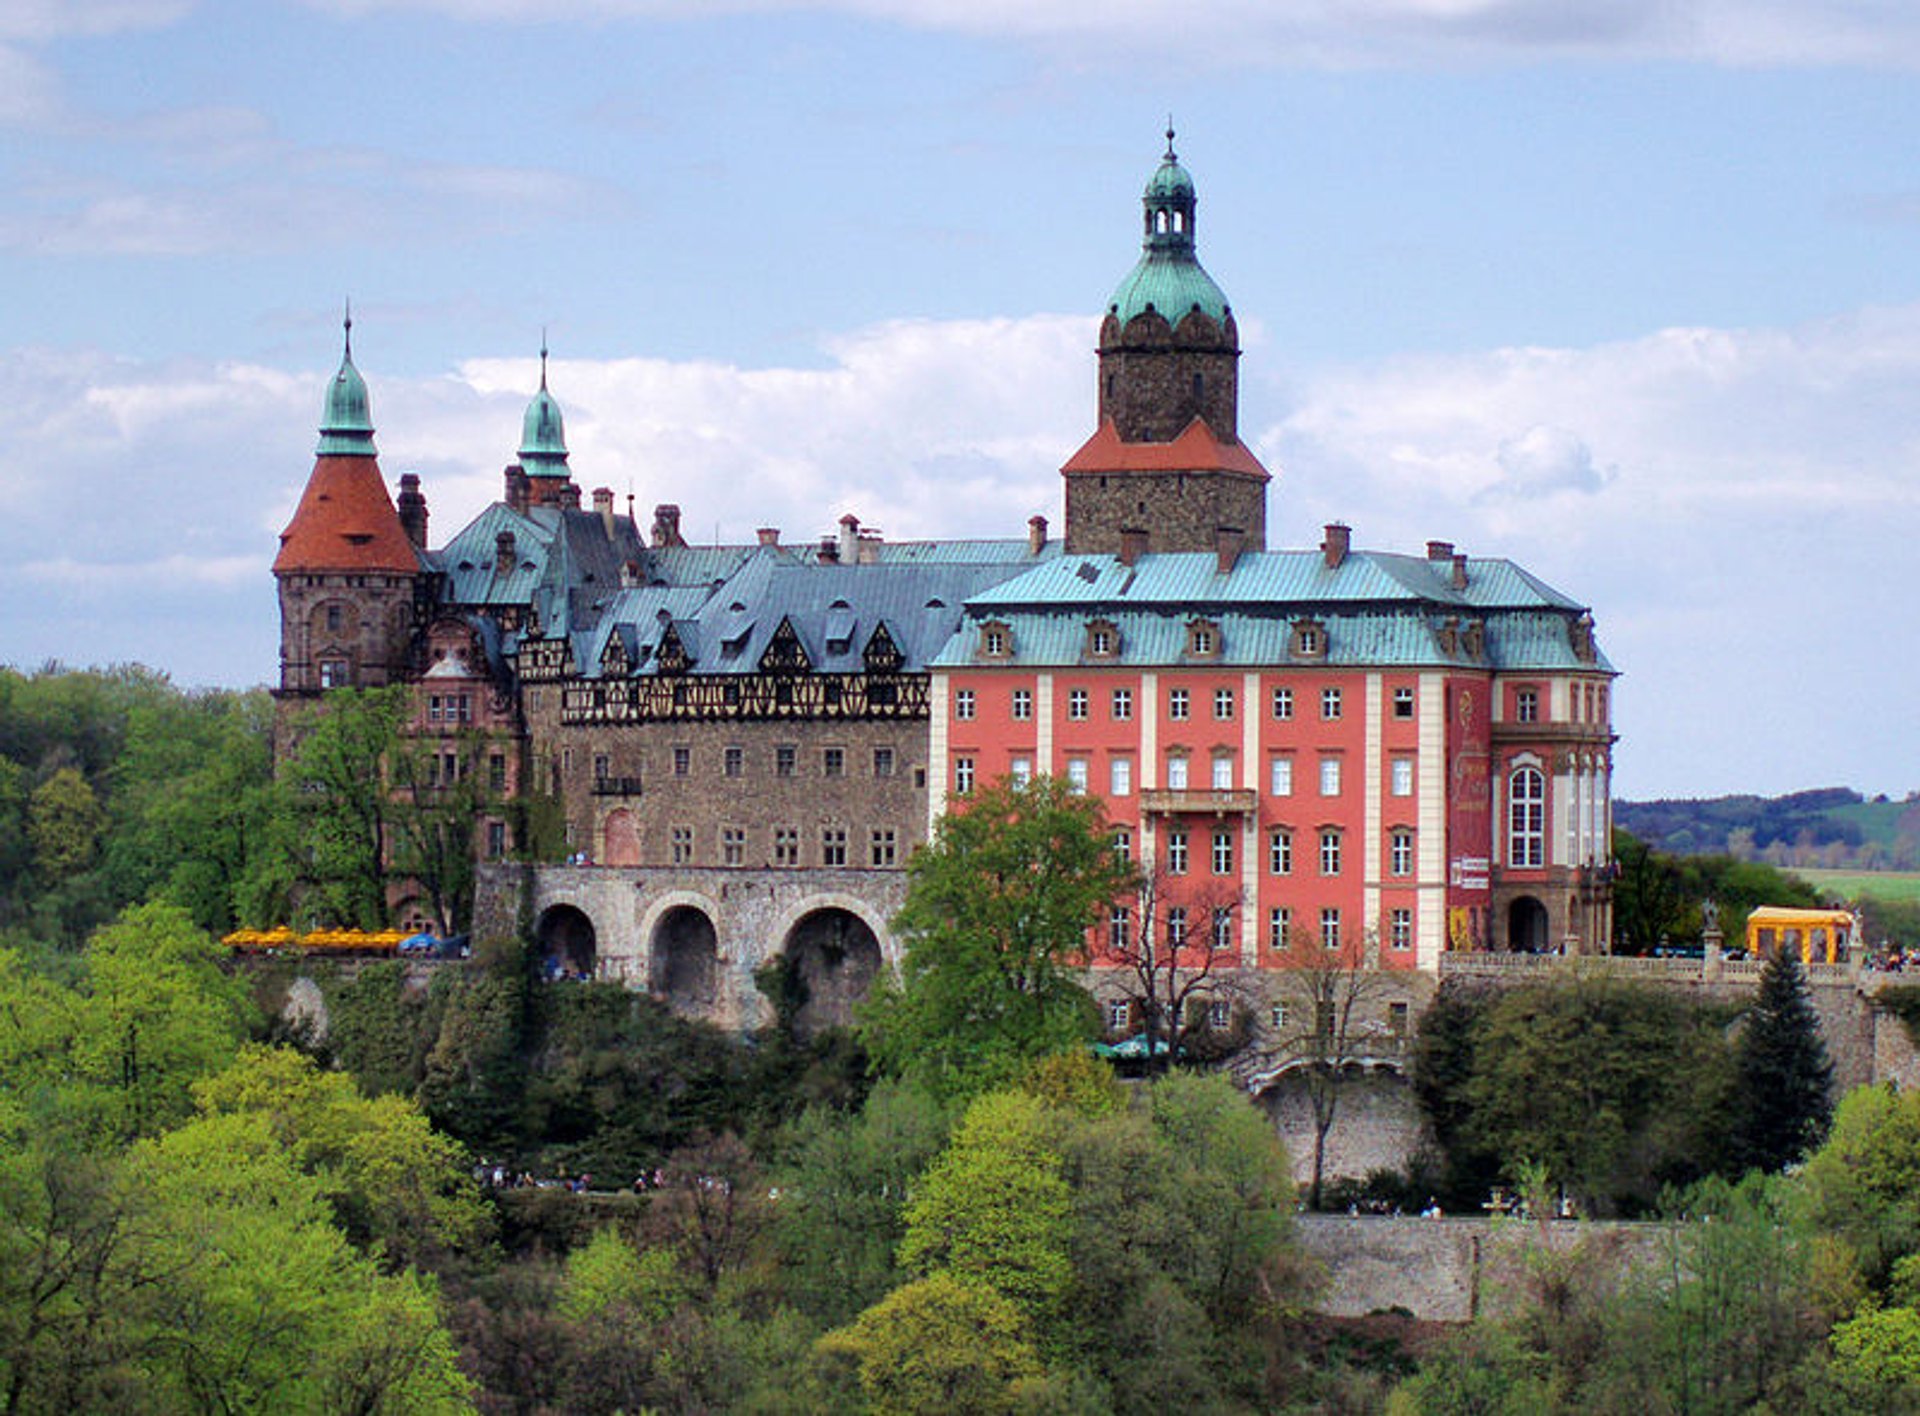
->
273;132;1613;1025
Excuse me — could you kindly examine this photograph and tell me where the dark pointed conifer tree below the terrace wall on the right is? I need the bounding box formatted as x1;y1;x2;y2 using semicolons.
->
1734;950;1834;1172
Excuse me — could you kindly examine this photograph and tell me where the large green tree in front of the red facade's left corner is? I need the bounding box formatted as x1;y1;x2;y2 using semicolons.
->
862;777;1131;1096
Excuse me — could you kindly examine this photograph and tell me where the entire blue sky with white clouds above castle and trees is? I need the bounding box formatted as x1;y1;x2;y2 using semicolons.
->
0;0;1920;798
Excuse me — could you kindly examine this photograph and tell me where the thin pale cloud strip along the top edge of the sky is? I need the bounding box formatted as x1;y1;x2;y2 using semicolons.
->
295;0;1920;67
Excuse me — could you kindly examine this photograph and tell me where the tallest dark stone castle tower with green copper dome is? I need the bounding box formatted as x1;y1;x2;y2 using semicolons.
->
1062;129;1271;555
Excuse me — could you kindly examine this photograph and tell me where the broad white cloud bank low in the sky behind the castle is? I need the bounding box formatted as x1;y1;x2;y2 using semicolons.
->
0;307;1920;794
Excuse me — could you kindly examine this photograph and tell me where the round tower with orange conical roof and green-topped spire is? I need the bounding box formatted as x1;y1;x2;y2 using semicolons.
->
273;319;426;696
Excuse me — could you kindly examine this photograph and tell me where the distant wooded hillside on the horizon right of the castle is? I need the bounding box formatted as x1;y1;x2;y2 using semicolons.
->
1613;787;1920;871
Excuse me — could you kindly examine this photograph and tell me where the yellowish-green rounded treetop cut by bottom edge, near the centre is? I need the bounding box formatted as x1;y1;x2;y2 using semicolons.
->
826;1272;1041;1416
